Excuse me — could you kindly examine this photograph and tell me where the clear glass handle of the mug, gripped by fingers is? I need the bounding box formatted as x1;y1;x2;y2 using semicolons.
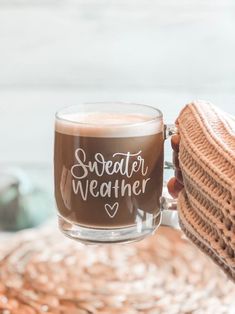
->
160;124;180;229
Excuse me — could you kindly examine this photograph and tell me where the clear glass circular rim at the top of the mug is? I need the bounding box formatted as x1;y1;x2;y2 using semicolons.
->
55;101;163;127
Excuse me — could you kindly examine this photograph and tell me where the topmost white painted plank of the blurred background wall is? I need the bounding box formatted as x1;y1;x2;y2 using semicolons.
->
0;0;235;91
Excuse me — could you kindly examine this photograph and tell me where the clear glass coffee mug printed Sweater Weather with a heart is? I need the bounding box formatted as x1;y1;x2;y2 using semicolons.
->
54;102;178;244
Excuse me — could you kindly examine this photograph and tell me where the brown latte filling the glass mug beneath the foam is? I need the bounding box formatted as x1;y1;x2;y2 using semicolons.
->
54;114;163;228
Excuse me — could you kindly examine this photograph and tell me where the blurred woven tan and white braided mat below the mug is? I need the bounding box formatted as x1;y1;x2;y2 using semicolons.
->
0;226;235;314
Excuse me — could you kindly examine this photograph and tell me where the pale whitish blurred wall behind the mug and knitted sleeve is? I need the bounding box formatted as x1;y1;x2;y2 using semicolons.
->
0;0;235;231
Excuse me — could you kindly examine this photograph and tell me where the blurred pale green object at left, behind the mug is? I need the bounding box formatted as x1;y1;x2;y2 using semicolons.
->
0;168;53;231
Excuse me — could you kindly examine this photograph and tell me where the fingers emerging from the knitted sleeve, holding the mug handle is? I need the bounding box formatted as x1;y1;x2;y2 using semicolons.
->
167;134;184;198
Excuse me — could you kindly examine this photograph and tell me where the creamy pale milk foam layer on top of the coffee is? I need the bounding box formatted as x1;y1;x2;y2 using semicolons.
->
55;112;163;137
